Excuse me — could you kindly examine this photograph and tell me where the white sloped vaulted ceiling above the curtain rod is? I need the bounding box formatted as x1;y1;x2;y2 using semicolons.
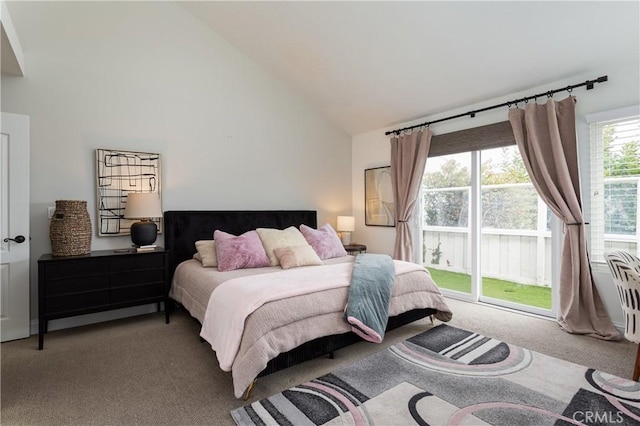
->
179;1;640;134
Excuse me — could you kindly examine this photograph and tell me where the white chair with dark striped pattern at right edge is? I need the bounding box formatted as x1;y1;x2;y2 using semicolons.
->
605;251;640;381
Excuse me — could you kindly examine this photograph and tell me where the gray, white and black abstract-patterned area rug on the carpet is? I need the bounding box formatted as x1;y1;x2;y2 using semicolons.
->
231;324;640;426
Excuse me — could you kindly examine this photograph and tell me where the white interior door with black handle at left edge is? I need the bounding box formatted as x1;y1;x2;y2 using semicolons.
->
0;112;30;342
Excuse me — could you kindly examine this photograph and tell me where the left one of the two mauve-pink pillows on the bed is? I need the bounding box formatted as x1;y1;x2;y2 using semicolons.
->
213;230;271;271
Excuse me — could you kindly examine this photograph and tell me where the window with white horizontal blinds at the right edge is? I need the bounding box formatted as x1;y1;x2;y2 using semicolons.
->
587;107;640;262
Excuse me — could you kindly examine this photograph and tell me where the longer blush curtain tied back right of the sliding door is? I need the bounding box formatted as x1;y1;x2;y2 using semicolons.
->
509;96;620;340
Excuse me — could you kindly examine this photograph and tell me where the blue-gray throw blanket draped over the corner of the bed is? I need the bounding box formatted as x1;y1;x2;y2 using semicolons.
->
344;253;396;343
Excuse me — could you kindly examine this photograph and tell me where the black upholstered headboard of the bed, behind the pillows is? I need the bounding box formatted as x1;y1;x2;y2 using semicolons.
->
164;210;318;275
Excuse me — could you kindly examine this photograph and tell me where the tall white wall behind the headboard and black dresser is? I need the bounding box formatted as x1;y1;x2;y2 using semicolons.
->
2;2;351;324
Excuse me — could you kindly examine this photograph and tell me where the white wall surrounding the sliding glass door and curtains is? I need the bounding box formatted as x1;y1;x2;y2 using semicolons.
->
352;62;640;325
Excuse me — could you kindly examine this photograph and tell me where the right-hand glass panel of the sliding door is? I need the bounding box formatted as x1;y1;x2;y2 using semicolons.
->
480;146;552;313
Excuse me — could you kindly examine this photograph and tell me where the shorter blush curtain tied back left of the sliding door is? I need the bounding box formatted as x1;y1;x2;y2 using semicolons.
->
391;128;432;262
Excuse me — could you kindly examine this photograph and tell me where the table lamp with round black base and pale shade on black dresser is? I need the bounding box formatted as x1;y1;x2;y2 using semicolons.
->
124;192;162;247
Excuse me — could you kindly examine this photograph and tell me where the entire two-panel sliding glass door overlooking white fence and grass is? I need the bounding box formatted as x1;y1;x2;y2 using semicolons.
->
423;146;553;315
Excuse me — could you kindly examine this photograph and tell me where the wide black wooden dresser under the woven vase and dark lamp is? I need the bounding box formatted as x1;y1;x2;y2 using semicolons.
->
38;247;169;349
